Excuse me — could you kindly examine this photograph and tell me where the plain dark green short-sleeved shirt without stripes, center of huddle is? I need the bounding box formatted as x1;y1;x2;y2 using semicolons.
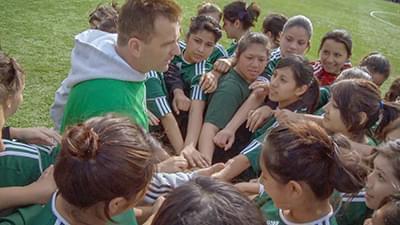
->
204;69;250;129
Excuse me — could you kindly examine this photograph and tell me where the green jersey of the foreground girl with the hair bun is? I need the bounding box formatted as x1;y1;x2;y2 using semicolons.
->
28;192;137;225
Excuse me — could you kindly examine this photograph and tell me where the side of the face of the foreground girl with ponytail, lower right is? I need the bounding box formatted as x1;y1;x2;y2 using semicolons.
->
261;160;293;209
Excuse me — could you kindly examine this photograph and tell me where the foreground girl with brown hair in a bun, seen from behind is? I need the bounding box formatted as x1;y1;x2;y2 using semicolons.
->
30;115;159;225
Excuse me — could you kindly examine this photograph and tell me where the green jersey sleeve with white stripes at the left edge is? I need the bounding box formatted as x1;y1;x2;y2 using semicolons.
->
0;139;55;187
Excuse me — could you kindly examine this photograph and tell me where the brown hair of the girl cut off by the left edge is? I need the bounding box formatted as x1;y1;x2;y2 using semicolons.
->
0;51;25;104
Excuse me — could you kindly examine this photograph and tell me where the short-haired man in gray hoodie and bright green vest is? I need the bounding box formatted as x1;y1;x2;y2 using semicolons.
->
51;0;181;131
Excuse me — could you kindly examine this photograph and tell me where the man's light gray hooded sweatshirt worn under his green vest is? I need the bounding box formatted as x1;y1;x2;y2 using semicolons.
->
50;30;146;130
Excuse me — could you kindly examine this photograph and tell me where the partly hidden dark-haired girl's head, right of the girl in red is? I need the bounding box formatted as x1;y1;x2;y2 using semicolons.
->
360;52;390;87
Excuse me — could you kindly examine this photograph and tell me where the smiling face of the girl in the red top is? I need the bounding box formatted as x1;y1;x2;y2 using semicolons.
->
319;39;349;74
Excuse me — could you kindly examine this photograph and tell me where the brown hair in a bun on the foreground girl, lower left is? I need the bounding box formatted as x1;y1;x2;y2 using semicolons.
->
54;115;159;219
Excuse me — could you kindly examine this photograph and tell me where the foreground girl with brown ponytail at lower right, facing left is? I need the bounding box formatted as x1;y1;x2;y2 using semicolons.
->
261;121;364;224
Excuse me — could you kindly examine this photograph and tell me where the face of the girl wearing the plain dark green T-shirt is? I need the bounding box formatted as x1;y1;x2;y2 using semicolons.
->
235;44;268;83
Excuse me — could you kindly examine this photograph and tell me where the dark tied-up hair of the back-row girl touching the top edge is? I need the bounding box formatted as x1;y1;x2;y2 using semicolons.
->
223;0;261;30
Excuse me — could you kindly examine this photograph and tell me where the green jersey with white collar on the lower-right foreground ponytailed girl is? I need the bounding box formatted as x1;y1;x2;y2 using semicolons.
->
254;192;337;225
